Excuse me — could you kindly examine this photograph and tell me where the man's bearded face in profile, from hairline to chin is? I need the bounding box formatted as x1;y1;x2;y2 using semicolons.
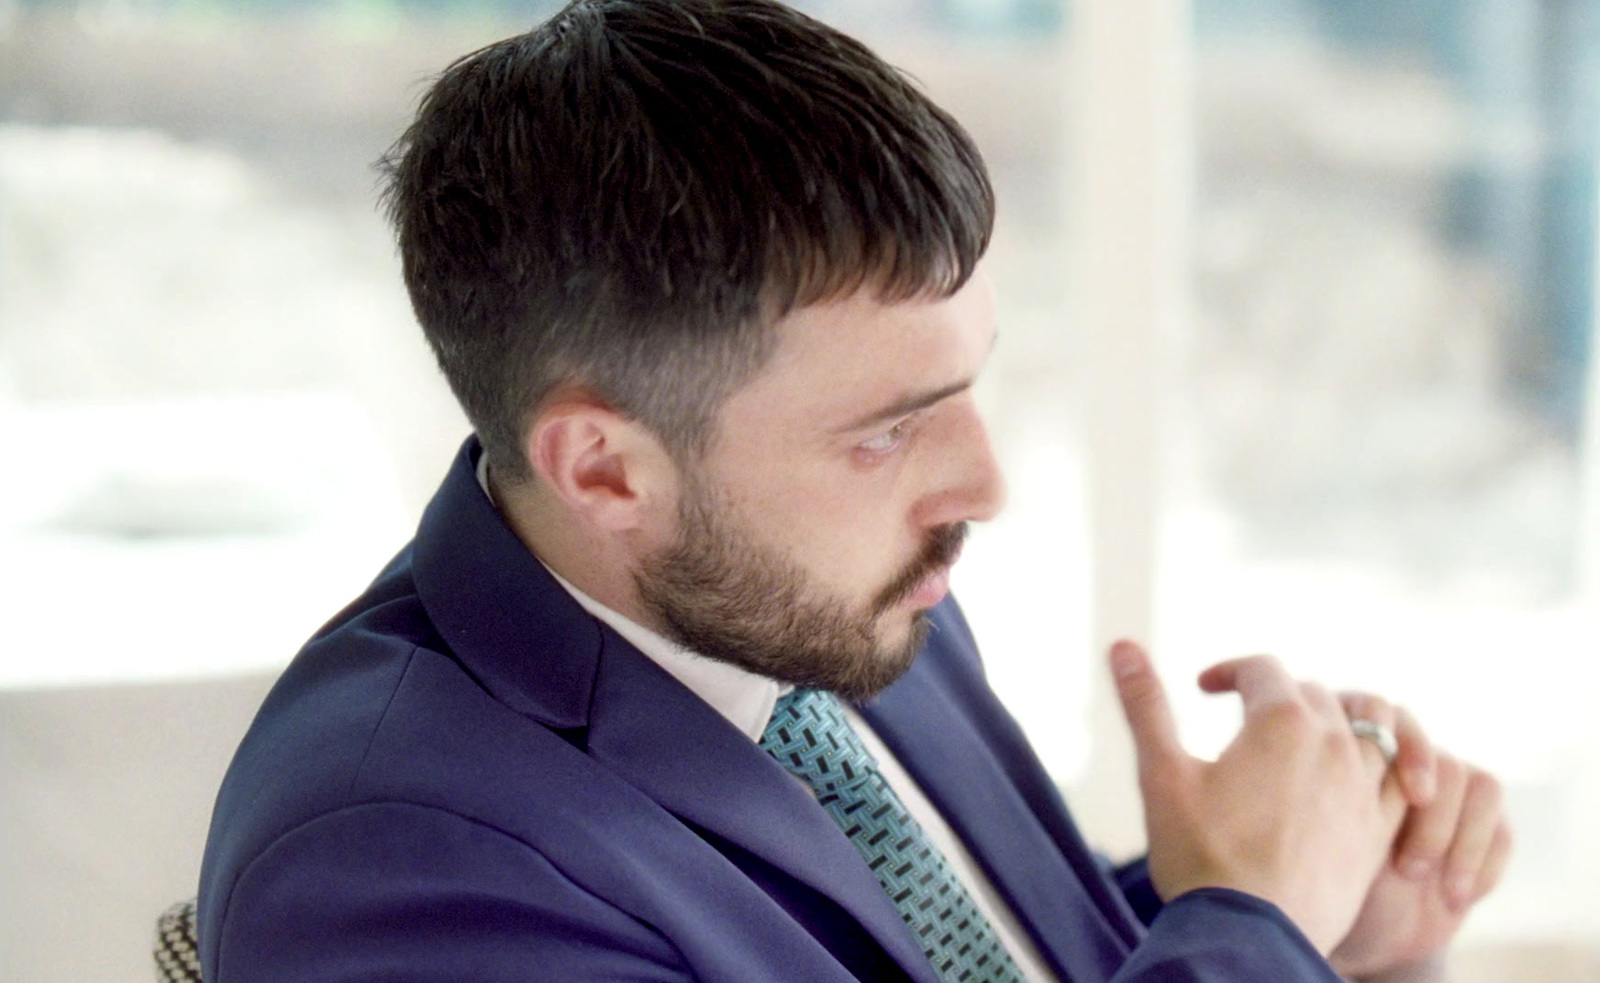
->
638;275;1003;698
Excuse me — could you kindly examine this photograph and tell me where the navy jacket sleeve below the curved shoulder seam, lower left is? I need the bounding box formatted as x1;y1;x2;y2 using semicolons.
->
202;802;691;983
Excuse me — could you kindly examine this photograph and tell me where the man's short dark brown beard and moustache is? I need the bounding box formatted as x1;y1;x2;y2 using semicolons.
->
635;482;966;700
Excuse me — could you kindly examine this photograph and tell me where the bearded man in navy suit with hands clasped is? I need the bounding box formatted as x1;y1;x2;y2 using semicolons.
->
200;0;1507;983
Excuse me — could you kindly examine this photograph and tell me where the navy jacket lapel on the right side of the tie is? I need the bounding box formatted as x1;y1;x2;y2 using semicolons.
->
861;656;1128;983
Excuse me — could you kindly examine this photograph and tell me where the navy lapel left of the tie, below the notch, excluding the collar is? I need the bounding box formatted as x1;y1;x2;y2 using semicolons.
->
589;631;938;983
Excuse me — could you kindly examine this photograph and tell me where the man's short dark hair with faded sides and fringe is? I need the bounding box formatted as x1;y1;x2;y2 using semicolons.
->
379;0;994;482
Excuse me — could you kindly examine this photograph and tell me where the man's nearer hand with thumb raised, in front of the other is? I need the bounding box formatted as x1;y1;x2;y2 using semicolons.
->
1110;642;1405;953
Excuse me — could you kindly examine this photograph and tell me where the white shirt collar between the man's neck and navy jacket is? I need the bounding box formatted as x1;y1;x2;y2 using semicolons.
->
477;455;794;741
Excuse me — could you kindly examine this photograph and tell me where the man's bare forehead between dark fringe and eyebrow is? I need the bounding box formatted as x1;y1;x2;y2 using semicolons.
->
720;271;995;434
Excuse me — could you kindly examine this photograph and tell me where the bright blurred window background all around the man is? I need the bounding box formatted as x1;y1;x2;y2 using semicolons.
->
0;0;1600;983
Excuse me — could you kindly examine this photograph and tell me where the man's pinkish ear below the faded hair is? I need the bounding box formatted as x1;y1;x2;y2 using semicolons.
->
526;392;677;533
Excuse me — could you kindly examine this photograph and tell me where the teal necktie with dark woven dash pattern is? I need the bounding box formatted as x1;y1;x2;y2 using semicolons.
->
762;690;1026;983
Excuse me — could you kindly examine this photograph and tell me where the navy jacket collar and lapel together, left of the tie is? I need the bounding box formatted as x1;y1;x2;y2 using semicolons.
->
413;439;938;983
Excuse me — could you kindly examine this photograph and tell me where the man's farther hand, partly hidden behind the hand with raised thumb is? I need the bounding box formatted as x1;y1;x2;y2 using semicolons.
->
1330;752;1510;980
